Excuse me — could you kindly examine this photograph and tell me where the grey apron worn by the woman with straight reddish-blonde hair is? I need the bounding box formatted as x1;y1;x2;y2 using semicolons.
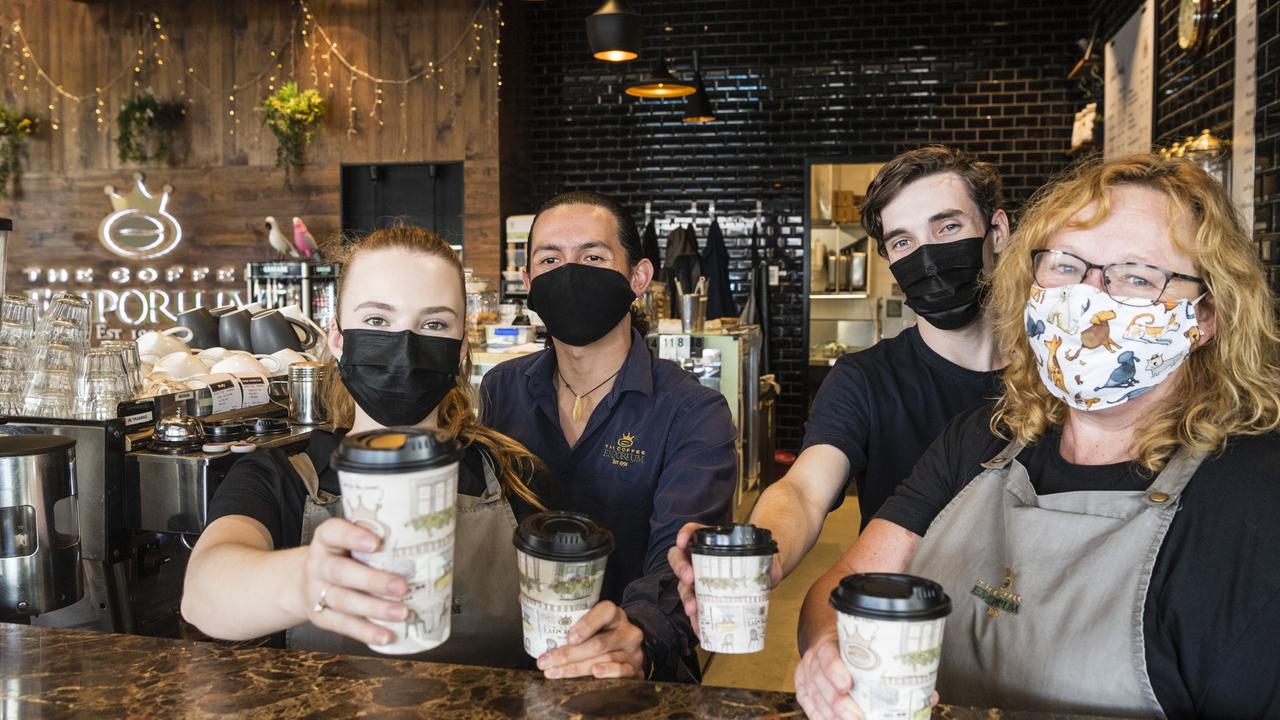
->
285;452;531;667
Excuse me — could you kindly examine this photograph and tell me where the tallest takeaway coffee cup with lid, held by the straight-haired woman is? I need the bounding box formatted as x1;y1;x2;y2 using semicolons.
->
333;428;461;655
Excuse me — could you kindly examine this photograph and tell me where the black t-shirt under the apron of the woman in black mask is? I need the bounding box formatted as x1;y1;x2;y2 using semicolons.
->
209;430;538;550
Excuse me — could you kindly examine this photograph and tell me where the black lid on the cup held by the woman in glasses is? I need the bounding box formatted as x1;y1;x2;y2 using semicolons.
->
831;573;951;620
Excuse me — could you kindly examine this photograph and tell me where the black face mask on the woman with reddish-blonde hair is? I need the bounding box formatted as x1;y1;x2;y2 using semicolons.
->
338;331;462;427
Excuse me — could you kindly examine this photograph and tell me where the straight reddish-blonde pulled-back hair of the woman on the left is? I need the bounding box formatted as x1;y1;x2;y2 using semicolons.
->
321;227;547;510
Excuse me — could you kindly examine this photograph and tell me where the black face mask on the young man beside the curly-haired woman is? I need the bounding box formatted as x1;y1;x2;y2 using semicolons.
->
888;236;987;331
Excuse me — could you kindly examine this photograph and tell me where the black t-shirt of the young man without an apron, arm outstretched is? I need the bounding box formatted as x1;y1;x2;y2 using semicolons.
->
804;327;1001;528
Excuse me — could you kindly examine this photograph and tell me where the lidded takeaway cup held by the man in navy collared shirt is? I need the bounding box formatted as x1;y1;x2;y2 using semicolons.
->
513;511;613;657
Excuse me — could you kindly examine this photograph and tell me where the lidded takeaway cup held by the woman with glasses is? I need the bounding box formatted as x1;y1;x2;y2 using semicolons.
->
829;573;951;720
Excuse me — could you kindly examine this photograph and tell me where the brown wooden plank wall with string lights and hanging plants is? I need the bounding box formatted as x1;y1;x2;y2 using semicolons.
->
0;0;500;330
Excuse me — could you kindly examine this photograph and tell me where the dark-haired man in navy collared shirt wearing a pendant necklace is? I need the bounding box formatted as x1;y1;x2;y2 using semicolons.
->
480;192;737;680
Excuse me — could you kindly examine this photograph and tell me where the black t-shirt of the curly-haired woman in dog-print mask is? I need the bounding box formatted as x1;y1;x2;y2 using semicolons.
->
877;405;1280;719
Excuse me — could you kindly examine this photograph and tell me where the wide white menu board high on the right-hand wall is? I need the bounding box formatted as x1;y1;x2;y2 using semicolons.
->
1102;0;1156;160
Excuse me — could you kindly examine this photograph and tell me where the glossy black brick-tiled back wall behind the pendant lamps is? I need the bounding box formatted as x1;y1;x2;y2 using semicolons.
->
508;0;1096;450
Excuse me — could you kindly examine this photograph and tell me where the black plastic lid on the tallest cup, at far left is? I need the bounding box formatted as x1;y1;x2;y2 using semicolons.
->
333;428;462;474
